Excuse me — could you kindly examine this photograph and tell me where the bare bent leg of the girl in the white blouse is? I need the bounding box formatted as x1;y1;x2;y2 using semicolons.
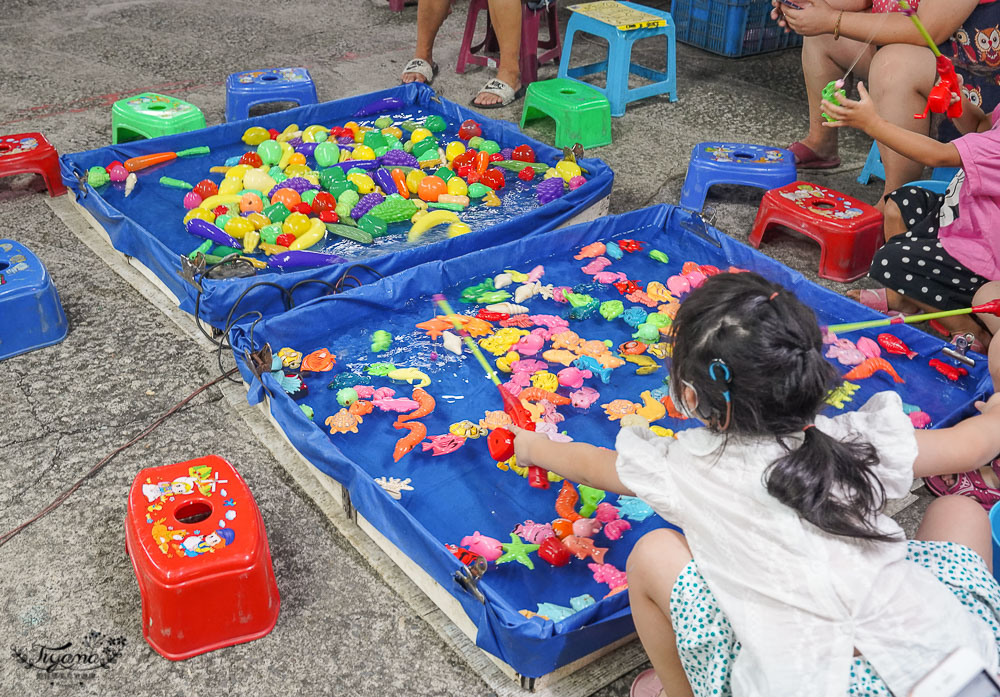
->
626;530;694;697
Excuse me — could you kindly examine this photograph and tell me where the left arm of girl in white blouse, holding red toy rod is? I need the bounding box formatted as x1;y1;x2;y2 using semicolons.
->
509;426;635;496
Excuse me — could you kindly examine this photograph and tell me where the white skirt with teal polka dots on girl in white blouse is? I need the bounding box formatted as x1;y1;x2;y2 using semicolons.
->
670;540;1000;697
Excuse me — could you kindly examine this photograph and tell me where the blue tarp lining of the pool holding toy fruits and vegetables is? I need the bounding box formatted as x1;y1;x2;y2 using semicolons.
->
60;83;614;327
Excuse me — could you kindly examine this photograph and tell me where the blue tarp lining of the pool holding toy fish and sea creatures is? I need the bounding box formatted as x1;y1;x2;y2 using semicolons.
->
230;206;989;677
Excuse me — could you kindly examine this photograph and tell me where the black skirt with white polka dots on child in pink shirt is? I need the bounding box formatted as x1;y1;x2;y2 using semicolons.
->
868;187;986;310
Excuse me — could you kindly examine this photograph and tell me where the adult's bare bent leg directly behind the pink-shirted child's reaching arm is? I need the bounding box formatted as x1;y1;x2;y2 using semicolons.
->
869;44;937;194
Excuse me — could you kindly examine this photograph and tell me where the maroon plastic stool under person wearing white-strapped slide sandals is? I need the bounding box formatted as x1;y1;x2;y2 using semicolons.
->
455;0;562;85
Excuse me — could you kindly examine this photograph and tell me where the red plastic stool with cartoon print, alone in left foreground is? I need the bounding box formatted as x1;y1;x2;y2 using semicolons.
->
125;455;281;661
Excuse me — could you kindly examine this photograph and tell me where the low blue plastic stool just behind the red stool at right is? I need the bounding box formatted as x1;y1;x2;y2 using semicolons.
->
681;143;798;211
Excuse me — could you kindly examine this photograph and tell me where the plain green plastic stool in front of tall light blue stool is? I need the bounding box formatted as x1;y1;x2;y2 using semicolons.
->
521;78;611;148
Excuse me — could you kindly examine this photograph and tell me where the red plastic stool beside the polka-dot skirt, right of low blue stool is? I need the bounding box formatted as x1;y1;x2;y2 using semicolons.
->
750;181;885;283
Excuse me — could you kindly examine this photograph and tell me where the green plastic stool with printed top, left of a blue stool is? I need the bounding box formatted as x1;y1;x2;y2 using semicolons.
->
111;92;205;144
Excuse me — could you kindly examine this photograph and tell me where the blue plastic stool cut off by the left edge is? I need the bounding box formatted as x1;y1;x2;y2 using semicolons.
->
0;240;69;361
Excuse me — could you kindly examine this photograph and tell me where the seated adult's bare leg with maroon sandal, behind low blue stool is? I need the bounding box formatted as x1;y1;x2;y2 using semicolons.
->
800;32;875;159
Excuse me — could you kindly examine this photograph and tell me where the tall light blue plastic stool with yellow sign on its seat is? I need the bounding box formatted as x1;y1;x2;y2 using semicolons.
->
559;2;677;116
